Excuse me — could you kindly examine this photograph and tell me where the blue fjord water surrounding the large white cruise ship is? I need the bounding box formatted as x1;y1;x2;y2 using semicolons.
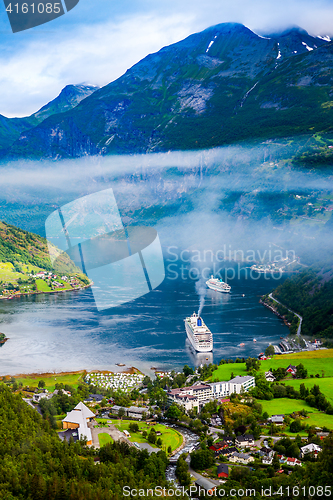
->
0;266;288;375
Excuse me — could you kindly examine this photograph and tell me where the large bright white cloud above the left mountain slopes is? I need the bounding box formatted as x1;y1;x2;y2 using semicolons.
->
0;15;195;117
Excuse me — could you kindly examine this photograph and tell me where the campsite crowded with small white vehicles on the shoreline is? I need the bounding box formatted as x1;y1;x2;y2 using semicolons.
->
85;372;144;392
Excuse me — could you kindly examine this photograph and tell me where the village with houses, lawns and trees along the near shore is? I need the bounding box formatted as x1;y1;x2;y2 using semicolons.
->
11;350;333;491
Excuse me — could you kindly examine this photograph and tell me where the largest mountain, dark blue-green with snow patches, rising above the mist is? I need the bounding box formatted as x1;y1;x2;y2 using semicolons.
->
2;23;333;158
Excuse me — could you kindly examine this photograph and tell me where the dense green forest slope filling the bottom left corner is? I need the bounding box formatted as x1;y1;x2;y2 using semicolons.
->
0;384;172;500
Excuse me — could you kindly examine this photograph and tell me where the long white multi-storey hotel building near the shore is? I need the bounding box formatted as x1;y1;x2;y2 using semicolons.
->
168;375;255;411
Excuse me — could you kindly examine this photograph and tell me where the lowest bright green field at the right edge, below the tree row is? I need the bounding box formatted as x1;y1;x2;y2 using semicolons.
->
259;398;333;435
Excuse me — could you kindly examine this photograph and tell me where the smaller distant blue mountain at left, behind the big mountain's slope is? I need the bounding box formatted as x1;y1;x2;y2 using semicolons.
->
0;85;99;149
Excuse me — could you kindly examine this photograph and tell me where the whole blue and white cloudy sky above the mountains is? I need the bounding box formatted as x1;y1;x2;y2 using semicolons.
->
0;0;333;117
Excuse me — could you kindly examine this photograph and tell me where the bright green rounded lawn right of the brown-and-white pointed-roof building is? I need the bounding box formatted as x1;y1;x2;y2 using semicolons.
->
108;420;183;451
